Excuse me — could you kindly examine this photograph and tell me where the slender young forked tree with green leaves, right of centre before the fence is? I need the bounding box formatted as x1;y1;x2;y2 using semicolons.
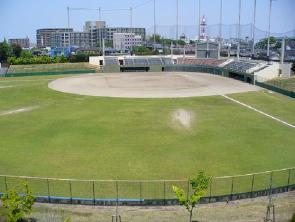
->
172;171;211;222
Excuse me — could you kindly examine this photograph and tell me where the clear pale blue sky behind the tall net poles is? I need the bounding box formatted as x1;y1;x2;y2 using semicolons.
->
0;0;295;42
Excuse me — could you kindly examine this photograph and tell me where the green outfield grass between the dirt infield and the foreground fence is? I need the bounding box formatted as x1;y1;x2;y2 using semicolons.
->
0;76;295;198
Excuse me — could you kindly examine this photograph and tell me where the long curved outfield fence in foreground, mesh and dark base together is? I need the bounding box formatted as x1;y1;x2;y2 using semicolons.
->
0;167;295;205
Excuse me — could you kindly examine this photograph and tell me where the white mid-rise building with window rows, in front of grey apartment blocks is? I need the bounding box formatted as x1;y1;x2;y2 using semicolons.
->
113;33;142;51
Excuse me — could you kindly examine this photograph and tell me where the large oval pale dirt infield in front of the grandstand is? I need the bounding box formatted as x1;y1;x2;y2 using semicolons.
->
49;72;259;98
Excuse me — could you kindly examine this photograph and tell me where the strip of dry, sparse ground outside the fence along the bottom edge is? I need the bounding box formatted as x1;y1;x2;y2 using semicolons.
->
28;191;295;222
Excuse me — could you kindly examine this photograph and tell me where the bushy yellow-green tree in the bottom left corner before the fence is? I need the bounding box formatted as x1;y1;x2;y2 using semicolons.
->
1;184;35;222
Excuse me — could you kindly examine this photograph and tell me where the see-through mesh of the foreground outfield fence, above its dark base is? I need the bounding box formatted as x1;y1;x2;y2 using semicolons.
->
0;168;295;203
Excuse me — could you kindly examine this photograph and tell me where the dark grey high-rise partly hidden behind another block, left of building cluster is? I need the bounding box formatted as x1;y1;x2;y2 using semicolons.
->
36;28;73;48
